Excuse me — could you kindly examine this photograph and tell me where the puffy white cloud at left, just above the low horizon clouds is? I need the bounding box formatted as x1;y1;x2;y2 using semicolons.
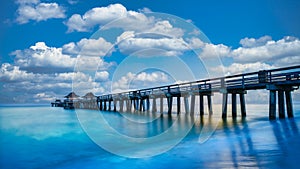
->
11;38;114;73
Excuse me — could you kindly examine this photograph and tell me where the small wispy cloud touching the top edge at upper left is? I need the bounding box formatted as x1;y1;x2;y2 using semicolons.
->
16;0;66;24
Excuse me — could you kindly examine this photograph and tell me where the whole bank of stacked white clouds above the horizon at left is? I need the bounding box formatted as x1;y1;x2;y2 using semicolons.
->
0;38;115;103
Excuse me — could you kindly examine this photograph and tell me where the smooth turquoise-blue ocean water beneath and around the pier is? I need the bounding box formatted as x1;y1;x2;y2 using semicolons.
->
0;104;300;169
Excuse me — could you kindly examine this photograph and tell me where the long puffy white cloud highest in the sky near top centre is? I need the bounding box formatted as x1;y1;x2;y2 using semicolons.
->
65;4;184;37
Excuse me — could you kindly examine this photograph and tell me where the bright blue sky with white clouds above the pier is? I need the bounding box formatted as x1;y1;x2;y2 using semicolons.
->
0;0;300;104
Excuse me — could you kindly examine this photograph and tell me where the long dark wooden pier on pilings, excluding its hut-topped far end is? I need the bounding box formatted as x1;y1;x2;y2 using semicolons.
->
94;65;300;120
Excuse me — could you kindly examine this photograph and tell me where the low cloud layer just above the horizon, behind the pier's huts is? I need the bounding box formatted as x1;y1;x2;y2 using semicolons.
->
0;63;108;103
